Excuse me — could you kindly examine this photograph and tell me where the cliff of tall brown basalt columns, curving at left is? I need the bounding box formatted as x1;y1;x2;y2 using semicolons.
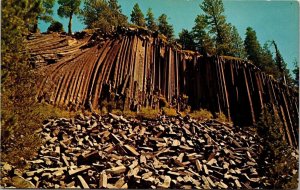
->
28;28;299;146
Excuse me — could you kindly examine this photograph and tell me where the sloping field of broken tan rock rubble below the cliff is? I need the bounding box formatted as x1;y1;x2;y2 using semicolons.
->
1;114;296;189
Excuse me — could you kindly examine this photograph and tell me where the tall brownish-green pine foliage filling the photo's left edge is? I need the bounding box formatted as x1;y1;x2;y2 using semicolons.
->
1;0;47;165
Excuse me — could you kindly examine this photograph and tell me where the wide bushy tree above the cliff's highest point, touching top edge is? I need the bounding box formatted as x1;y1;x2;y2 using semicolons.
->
81;0;127;32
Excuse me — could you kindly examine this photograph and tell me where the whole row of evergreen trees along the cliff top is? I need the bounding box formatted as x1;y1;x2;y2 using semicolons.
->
20;0;299;86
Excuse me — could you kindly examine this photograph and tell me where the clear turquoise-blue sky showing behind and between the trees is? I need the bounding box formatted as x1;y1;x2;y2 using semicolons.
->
39;0;300;70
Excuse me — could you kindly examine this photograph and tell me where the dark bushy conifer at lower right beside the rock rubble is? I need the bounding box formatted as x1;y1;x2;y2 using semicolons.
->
256;108;298;189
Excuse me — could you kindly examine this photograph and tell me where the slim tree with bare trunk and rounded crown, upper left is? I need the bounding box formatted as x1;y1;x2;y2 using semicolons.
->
57;0;81;34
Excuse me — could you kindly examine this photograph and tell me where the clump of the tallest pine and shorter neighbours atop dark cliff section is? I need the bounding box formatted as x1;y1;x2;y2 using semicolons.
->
192;0;245;58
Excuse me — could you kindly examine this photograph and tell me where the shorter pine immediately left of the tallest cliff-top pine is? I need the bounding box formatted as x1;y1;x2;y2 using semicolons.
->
192;15;215;54
